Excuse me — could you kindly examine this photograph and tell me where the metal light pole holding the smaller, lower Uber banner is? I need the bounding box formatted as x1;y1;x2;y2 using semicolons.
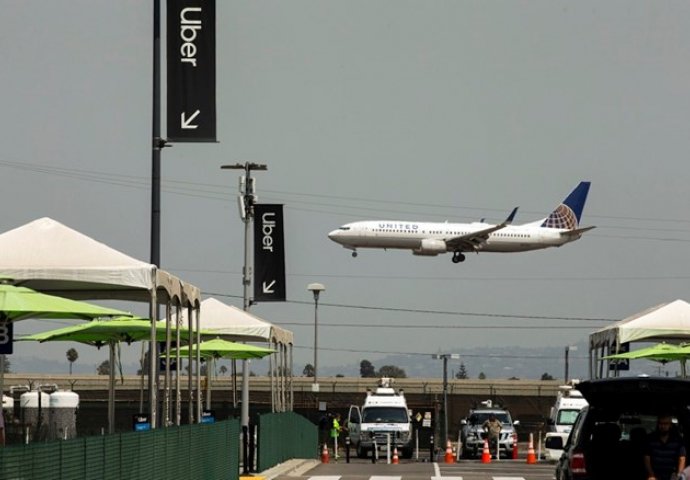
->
220;162;268;427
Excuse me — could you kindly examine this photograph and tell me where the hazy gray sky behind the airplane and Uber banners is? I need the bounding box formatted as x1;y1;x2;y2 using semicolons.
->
0;0;690;378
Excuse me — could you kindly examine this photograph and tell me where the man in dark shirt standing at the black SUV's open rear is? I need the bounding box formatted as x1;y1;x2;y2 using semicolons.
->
644;414;685;480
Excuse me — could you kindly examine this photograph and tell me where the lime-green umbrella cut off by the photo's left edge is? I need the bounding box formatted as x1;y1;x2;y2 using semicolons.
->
0;275;132;414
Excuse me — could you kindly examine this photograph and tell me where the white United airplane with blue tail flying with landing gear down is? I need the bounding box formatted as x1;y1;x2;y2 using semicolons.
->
328;182;595;263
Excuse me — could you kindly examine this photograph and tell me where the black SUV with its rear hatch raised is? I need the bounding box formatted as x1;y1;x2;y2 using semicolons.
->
546;377;690;480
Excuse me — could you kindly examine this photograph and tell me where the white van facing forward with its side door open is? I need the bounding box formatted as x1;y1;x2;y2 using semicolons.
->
347;378;413;458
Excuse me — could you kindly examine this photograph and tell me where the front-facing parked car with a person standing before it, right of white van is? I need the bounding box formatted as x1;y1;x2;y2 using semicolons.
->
460;406;520;458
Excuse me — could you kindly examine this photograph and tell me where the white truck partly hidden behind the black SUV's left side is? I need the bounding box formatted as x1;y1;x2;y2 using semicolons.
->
544;380;587;462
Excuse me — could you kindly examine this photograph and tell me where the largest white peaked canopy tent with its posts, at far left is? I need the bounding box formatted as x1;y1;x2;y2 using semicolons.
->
0;217;201;426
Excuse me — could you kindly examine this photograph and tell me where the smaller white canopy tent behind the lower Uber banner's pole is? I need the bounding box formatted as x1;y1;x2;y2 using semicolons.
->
175;297;294;412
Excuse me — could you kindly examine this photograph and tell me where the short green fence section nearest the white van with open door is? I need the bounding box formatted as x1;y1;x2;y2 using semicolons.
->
257;412;318;472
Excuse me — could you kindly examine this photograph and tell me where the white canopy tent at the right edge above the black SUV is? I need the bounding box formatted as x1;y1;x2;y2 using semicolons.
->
589;300;690;378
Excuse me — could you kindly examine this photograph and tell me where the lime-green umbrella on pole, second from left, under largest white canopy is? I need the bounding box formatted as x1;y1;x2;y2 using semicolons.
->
18;317;188;433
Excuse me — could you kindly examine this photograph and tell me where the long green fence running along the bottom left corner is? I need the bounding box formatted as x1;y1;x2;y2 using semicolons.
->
0;419;240;480
